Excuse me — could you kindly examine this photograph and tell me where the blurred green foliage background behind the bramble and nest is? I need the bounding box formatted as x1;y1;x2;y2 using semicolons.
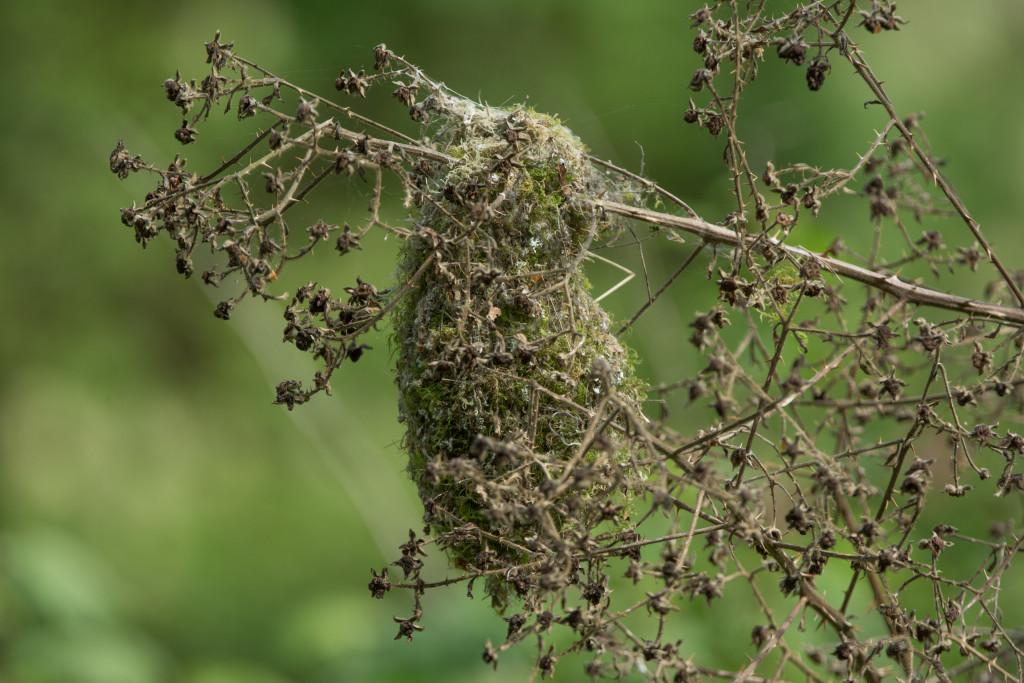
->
0;0;1024;683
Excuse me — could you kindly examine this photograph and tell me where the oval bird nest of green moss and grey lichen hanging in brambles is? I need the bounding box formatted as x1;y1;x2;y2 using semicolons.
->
394;92;646;601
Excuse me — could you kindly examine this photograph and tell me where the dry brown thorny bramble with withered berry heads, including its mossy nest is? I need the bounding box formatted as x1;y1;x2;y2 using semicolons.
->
111;0;1024;681
